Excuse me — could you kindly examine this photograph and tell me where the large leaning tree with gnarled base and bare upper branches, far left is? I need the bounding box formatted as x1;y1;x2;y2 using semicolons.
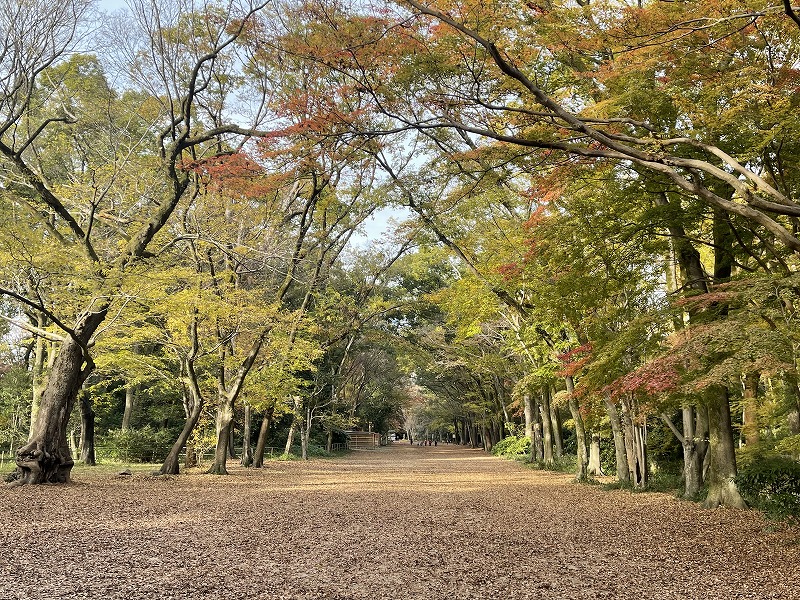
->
0;1;272;483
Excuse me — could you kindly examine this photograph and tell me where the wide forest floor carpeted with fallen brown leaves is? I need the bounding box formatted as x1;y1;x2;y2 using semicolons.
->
0;443;800;600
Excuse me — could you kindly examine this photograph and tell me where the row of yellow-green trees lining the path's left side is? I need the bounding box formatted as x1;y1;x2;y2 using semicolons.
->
0;1;418;483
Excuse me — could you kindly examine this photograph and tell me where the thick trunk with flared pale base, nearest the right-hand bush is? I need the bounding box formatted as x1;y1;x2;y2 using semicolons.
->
703;386;747;508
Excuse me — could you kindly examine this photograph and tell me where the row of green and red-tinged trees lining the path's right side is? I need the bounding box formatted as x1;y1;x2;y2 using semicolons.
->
288;0;800;506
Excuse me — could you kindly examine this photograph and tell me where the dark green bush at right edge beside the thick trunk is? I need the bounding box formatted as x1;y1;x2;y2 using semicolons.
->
735;455;800;521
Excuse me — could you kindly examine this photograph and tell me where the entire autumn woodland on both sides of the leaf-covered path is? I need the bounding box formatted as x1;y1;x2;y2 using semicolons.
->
0;0;800;510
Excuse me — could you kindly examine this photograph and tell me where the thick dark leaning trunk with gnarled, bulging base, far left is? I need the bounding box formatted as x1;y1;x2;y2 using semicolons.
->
14;311;106;485
